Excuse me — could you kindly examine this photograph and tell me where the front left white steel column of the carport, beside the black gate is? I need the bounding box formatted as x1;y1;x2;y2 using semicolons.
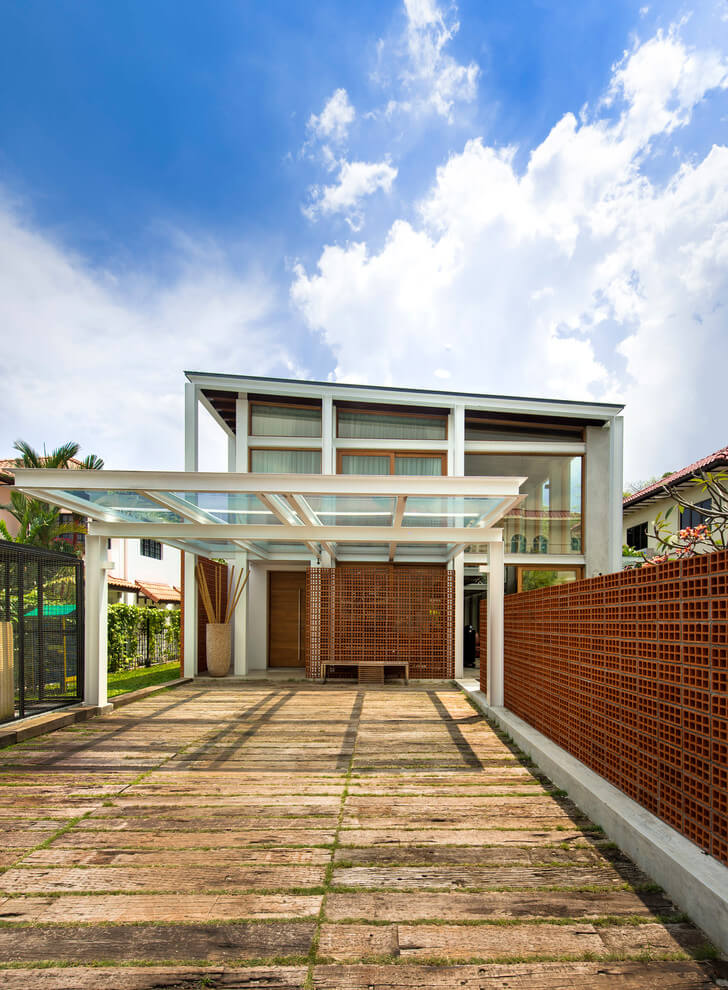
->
83;536;111;708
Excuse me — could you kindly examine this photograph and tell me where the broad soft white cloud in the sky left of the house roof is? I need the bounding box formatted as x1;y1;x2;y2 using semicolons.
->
0;202;298;469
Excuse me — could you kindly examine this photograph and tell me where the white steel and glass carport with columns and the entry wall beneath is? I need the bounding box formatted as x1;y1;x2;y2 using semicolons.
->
16;470;525;704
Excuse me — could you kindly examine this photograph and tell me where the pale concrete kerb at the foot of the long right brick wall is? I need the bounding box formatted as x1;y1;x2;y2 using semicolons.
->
456;681;728;953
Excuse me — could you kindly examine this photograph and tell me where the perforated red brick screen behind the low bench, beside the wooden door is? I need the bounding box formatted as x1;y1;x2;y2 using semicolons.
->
306;564;455;678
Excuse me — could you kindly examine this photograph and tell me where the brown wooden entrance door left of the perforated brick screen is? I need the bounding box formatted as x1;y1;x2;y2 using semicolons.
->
268;571;306;667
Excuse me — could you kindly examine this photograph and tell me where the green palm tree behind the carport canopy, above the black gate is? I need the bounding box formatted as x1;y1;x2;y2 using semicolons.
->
0;440;104;553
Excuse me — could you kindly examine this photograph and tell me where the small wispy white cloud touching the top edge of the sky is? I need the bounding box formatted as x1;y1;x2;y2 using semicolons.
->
390;0;480;120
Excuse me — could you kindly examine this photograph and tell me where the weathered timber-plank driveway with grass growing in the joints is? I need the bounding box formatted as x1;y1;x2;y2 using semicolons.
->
0;680;715;990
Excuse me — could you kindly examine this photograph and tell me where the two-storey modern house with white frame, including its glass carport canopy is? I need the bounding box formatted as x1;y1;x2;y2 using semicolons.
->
11;372;623;688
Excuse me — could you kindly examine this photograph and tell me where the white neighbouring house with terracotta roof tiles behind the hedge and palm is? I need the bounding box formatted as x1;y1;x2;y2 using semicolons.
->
0;458;180;605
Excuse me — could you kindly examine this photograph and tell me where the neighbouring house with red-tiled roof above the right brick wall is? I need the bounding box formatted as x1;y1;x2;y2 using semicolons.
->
622;447;728;552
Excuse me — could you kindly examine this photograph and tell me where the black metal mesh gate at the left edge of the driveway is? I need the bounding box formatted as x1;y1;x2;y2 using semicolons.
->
0;540;84;722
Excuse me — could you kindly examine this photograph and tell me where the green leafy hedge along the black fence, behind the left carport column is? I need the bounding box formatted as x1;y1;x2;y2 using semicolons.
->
107;604;180;673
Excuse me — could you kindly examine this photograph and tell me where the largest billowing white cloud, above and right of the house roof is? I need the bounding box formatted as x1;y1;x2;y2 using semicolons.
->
291;25;728;477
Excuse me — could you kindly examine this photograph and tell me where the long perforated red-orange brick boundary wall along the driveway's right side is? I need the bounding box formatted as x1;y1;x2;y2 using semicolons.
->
481;551;728;863
